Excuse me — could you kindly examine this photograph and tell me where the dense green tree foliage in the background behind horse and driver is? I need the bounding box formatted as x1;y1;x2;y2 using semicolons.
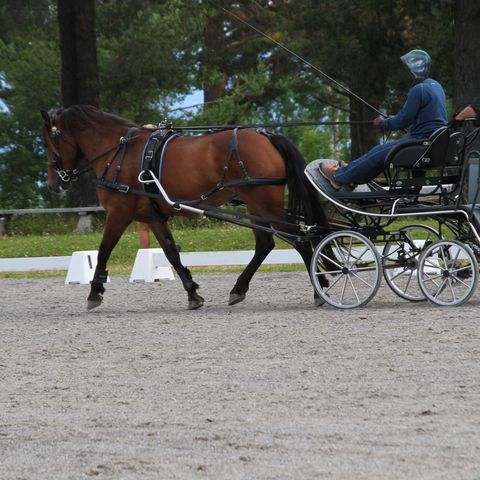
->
0;0;468;208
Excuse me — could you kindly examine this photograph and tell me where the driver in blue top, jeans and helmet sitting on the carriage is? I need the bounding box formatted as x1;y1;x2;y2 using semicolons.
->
320;50;448;190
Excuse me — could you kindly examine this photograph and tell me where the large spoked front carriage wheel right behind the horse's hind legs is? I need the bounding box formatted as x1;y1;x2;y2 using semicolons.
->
310;231;382;308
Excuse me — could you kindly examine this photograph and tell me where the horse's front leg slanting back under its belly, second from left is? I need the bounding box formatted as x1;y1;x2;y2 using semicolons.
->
150;222;204;310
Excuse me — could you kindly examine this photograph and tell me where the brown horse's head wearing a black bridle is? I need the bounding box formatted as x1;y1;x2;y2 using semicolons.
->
40;108;83;193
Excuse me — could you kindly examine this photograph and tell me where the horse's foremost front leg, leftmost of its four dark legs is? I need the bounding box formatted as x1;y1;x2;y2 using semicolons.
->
87;214;131;310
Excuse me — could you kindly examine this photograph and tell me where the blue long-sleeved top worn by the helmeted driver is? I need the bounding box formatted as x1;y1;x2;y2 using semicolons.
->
383;78;448;138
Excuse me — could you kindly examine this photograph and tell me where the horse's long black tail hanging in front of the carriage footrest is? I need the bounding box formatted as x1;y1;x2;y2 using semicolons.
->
269;135;328;226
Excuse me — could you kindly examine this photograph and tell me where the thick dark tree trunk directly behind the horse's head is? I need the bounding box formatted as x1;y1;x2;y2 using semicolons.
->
58;0;98;207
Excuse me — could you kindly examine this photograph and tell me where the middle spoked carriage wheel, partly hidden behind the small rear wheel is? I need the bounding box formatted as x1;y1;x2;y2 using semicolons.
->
382;225;440;302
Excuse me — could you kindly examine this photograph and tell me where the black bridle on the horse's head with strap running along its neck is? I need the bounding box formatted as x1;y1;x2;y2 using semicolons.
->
47;119;133;183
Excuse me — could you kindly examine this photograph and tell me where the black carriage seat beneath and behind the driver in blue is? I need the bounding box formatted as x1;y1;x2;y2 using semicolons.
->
385;127;462;169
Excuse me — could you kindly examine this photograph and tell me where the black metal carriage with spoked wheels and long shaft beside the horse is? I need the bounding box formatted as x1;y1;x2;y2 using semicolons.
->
139;120;480;308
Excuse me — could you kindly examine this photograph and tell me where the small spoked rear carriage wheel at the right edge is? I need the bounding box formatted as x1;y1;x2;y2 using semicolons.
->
418;240;478;306
